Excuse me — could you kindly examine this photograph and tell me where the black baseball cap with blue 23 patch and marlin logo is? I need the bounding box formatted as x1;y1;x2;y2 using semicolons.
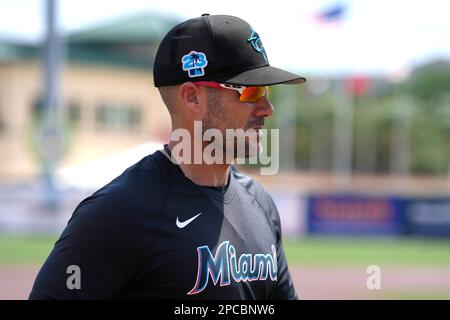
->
153;14;306;87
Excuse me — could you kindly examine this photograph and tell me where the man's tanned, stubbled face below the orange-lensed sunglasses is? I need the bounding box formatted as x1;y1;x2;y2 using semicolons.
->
203;88;273;158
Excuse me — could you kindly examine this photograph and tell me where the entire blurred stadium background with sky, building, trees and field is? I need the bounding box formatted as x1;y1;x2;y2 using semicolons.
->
0;0;450;299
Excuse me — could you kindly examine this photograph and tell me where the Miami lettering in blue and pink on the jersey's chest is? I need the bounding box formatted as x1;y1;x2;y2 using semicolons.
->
187;241;278;295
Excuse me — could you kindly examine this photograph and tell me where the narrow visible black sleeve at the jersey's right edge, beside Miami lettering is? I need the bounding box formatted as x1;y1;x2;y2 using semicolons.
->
267;194;298;300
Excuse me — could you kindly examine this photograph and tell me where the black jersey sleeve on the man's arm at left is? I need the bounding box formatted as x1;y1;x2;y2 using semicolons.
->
29;188;154;299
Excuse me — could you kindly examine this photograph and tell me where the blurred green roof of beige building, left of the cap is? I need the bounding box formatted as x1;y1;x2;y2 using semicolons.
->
0;13;179;68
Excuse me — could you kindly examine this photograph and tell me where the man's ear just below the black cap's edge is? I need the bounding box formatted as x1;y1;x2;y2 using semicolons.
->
178;82;207;119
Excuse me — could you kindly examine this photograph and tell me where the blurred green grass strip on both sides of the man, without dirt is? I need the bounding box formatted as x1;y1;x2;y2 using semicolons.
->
0;235;450;267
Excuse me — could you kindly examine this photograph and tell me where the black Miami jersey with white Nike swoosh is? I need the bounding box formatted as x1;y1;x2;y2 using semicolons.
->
30;151;297;299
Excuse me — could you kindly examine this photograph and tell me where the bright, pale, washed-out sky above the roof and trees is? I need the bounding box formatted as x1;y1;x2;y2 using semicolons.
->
0;0;450;76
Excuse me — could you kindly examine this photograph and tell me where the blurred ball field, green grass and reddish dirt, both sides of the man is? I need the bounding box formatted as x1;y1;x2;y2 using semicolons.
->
0;235;450;300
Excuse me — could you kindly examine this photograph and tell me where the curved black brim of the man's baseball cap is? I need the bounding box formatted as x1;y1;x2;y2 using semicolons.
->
214;66;306;86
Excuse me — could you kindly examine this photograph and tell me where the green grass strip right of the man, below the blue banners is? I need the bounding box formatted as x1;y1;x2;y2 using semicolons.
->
284;238;450;267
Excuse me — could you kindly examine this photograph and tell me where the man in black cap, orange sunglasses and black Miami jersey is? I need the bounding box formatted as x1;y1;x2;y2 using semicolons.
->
30;15;305;299
